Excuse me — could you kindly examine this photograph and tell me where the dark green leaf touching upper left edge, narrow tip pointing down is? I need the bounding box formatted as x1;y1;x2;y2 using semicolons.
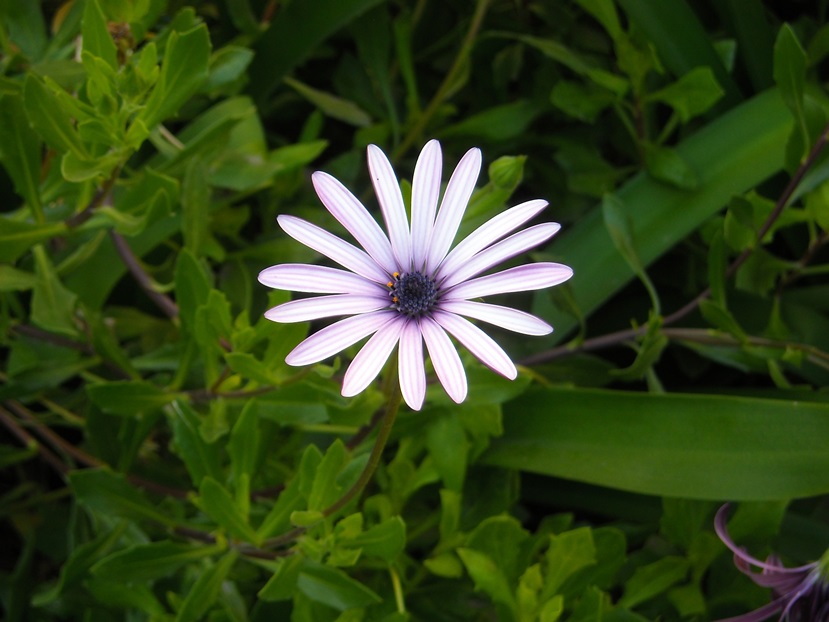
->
0;93;43;222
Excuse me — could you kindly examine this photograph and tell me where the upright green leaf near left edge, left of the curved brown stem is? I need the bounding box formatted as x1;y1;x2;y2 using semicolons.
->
32;244;78;335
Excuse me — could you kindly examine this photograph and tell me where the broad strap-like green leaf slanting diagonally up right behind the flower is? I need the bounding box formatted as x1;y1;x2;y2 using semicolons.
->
535;91;792;350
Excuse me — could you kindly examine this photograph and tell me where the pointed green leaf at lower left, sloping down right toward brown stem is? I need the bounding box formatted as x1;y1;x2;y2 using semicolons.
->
69;468;176;526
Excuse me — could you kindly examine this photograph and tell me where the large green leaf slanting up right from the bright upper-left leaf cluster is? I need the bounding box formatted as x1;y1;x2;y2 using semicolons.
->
138;24;210;129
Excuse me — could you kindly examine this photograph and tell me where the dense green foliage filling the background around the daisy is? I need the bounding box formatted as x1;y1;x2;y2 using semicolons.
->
0;0;829;622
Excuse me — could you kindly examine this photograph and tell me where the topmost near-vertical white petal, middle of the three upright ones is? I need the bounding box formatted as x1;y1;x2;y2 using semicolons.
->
412;140;443;270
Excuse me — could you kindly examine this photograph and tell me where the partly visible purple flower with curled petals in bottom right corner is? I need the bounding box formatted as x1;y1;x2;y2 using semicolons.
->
714;503;829;622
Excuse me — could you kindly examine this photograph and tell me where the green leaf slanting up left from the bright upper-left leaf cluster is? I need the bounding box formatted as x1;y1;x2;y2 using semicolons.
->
23;73;89;160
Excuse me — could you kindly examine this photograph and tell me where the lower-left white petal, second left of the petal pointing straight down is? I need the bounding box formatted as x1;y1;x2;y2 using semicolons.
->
285;311;400;367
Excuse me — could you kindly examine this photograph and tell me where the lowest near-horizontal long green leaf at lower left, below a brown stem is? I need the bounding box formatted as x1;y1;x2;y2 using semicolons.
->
92;540;225;583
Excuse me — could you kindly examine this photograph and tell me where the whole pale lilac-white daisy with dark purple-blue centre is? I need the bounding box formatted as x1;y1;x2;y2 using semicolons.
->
259;140;573;410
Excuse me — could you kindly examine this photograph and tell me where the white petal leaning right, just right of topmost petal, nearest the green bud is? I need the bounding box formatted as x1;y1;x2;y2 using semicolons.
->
426;148;481;274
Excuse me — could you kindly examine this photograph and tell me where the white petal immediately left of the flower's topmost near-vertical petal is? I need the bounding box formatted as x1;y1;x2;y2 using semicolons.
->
368;145;412;271
